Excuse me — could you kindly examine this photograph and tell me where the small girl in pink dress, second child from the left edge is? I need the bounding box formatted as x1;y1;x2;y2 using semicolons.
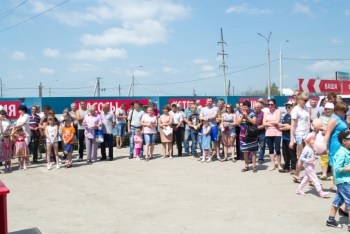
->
11;127;29;170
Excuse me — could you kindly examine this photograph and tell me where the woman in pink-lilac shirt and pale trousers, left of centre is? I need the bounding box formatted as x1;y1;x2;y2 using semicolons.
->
83;105;102;163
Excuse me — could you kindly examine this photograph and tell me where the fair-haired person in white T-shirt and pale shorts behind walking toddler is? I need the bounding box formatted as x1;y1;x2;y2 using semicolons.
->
289;92;310;183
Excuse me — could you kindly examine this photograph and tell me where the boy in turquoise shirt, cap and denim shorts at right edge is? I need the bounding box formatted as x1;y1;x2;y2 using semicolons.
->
326;129;350;231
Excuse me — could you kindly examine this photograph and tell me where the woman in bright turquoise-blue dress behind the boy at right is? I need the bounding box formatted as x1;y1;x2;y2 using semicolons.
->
324;102;349;192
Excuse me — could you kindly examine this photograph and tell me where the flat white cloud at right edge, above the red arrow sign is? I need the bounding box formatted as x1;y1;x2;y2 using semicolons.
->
306;60;350;73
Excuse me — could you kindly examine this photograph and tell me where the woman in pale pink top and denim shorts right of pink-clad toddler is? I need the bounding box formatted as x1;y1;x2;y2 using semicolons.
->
141;106;158;162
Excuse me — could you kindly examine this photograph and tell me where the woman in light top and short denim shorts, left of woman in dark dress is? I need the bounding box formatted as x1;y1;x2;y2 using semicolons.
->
221;104;237;162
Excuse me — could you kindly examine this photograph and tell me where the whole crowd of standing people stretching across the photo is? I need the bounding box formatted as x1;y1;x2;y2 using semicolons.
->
0;90;350;231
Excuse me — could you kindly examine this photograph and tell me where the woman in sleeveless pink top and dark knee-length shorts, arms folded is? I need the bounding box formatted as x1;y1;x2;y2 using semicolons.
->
263;99;287;172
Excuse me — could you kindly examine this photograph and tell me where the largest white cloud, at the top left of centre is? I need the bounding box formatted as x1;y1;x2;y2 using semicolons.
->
32;0;191;47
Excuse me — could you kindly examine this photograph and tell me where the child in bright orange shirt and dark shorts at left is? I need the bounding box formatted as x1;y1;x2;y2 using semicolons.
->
62;118;75;168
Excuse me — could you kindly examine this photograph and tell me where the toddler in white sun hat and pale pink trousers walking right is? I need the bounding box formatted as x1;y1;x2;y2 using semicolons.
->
296;133;329;197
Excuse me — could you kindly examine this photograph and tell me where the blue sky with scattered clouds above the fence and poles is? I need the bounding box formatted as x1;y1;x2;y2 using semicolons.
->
0;0;350;97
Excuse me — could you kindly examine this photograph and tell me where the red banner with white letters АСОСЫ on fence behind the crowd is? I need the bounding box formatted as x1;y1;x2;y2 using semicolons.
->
75;99;148;113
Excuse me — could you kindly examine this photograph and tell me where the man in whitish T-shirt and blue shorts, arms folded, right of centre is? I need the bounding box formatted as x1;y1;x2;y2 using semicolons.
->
199;97;221;161
